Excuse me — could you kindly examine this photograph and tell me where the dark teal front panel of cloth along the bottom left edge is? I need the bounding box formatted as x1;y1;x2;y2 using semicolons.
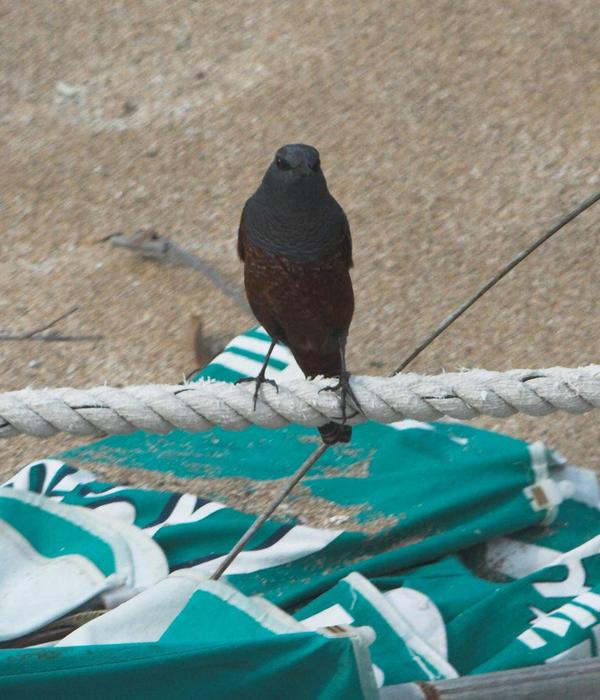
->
0;633;375;700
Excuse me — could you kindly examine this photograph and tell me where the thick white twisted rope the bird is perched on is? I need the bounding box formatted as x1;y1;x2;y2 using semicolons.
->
0;365;600;438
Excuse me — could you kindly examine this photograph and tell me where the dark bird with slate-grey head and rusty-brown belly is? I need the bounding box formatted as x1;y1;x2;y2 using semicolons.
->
237;144;360;445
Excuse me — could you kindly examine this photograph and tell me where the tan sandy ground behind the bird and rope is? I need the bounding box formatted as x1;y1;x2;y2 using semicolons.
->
0;0;600;492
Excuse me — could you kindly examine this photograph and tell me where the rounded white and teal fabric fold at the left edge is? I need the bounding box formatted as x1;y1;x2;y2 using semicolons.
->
0;488;168;641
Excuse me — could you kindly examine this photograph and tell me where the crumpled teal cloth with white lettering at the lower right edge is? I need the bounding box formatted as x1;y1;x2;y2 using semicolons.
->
454;501;600;674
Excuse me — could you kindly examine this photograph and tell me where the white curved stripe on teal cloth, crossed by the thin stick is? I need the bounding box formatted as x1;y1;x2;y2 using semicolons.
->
193;525;343;576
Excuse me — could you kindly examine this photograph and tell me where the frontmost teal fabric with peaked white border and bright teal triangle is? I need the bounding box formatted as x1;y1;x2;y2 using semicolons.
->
0;571;379;700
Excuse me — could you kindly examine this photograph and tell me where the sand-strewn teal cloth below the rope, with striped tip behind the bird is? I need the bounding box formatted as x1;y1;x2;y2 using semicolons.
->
57;329;556;609
